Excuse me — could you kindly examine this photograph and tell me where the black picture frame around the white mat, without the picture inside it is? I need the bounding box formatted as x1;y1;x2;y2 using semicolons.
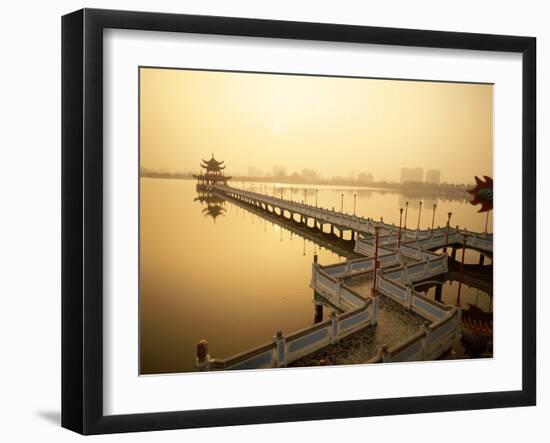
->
62;9;536;434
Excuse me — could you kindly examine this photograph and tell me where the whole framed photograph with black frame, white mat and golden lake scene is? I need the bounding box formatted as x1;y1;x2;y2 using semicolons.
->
62;9;536;434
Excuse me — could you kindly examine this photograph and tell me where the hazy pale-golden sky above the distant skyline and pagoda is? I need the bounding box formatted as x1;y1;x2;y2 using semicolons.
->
140;68;493;183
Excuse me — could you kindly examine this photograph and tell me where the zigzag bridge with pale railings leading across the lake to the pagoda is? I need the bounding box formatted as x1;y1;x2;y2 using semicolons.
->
196;183;493;371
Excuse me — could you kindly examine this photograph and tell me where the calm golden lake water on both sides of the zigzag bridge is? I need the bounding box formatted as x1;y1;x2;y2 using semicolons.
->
140;178;491;374
